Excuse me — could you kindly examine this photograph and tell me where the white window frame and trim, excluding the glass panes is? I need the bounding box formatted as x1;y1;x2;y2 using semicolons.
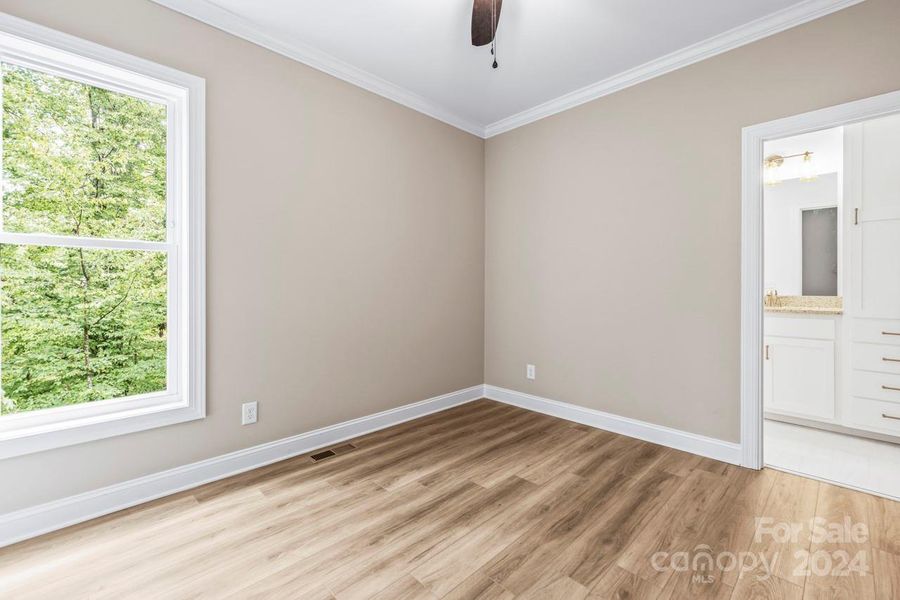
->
0;13;206;459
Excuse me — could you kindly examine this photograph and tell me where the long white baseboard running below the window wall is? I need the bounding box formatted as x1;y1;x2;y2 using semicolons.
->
0;385;484;547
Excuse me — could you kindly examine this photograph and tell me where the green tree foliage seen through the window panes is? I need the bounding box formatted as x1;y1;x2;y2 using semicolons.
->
0;64;167;414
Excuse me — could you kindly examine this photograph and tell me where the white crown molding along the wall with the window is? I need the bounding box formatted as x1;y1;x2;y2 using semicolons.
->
152;0;484;138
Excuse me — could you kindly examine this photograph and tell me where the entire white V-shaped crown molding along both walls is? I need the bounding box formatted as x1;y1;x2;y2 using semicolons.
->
152;0;865;138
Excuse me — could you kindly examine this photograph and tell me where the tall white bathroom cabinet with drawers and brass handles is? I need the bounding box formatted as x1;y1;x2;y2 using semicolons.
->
842;116;900;435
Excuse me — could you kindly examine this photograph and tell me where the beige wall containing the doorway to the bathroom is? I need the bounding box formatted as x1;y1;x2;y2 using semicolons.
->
485;0;900;441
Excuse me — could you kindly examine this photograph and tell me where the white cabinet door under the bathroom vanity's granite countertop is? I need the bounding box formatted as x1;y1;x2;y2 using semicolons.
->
763;336;835;419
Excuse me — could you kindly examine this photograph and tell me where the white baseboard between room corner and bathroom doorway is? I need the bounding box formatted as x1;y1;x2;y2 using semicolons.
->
484;385;741;465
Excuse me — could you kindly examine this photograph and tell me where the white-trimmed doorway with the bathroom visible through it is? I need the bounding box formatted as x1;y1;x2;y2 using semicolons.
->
741;92;900;499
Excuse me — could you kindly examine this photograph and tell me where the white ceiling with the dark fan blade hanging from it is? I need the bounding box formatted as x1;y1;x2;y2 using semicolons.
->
156;0;860;134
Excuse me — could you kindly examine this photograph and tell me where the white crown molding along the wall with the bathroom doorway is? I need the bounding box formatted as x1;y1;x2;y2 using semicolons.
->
484;0;865;138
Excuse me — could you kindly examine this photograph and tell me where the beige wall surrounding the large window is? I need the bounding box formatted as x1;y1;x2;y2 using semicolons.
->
0;0;484;513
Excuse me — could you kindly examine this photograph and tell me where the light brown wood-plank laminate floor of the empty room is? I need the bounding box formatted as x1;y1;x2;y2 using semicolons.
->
0;400;900;600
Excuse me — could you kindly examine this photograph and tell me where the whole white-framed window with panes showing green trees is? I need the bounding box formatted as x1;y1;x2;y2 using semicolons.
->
0;16;205;458
